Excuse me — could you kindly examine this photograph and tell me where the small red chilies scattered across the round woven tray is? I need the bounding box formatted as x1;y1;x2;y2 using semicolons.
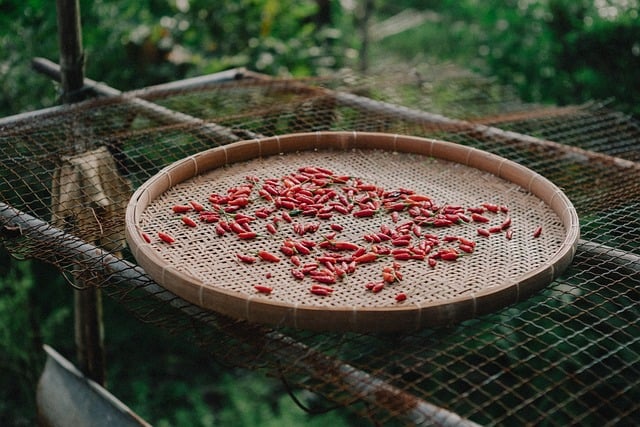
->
143;166;542;302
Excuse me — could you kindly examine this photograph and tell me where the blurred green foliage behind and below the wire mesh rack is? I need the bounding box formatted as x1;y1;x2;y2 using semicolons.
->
0;0;640;426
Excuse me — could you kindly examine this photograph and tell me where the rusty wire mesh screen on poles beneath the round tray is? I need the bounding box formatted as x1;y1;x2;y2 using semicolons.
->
0;67;640;426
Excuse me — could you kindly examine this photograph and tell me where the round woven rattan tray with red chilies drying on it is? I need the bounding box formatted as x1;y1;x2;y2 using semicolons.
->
126;132;579;332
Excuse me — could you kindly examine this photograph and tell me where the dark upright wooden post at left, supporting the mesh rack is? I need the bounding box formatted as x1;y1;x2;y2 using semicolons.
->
56;0;106;385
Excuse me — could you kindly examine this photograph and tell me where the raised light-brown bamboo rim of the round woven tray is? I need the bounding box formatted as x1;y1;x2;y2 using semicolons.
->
125;131;580;332
